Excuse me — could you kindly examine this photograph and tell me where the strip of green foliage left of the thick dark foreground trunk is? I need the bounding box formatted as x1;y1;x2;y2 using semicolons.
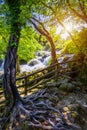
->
0;3;10;58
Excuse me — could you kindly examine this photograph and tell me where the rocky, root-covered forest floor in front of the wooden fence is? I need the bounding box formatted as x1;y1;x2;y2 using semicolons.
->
0;81;87;130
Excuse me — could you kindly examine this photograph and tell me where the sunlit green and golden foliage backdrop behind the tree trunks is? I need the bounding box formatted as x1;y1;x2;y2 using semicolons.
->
0;0;87;61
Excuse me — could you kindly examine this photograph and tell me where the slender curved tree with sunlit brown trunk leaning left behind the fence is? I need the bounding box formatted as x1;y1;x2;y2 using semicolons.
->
21;0;57;63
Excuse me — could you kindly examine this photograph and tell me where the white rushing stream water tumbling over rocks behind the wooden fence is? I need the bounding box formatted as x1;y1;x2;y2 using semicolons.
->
0;50;74;78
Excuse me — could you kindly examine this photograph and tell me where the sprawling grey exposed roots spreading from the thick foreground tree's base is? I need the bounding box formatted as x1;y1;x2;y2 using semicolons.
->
3;89;72;130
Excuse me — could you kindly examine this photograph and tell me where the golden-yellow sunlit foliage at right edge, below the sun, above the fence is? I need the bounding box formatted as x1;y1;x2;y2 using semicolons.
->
63;28;87;62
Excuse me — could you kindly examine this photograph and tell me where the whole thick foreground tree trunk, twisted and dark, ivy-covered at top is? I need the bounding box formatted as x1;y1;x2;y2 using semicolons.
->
3;0;21;107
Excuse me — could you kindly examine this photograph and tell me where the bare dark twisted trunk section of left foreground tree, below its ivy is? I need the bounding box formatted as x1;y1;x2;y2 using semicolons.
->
3;34;20;105
